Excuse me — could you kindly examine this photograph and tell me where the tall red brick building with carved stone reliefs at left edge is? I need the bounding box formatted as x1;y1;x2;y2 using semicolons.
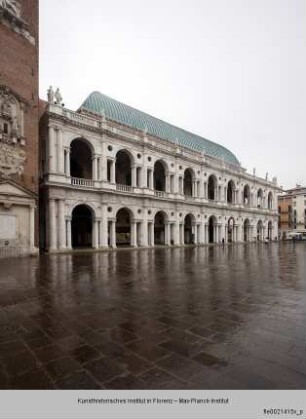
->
0;0;39;257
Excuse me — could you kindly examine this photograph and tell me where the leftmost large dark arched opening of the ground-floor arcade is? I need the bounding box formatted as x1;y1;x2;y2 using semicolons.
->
71;205;93;249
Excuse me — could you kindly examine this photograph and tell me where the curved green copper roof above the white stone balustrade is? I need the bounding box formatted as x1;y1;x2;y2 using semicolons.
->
80;92;239;165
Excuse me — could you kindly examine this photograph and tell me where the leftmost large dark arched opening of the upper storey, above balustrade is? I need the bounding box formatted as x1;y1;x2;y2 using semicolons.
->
70;139;92;179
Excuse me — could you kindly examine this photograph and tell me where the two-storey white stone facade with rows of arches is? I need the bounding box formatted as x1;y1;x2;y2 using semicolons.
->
40;104;278;252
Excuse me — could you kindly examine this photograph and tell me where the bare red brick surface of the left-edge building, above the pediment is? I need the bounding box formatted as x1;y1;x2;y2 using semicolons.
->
0;0;39;193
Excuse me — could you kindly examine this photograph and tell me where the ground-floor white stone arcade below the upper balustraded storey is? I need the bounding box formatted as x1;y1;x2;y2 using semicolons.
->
45;190;277;252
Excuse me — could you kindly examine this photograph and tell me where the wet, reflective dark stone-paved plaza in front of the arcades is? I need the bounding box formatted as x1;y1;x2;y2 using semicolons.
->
0;243;306;389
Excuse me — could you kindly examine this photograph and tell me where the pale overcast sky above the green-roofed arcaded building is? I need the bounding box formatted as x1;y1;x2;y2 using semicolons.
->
40;0;306;188
